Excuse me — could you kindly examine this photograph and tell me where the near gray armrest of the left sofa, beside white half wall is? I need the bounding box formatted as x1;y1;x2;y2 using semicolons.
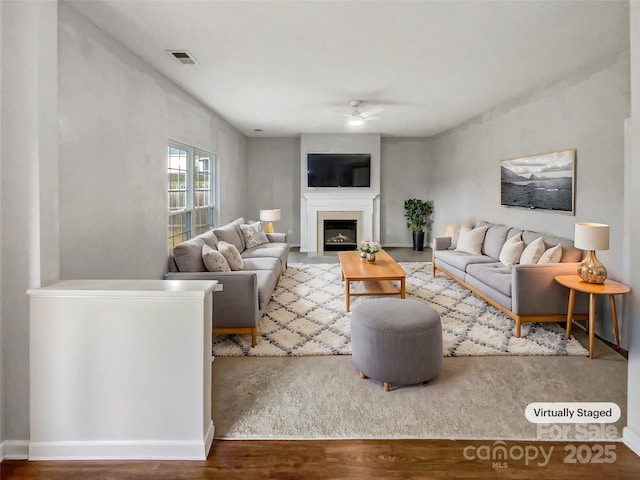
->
164;271;260;328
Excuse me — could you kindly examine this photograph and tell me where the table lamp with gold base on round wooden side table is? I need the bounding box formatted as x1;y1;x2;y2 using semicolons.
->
574;223;609;283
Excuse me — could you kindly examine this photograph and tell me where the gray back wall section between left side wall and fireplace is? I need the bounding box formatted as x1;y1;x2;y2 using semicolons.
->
245;138;300;245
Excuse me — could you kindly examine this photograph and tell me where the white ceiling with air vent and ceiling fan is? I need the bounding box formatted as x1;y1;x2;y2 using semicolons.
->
67;0;629;137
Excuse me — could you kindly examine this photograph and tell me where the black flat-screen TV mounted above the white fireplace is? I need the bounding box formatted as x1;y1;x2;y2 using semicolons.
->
307;153;371;187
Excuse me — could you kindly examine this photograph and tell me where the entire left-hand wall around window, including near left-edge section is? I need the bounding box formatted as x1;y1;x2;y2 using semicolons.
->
0;1;248;452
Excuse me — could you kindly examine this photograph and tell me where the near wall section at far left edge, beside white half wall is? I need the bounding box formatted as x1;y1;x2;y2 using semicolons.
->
0;2;59;450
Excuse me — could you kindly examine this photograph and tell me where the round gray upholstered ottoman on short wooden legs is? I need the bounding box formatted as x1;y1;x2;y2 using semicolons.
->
351;298;442;391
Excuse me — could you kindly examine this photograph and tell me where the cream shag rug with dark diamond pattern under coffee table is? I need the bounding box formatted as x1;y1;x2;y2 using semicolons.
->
213;262;589;357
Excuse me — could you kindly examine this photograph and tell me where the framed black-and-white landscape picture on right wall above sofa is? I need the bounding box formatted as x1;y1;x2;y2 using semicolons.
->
500;149;576;215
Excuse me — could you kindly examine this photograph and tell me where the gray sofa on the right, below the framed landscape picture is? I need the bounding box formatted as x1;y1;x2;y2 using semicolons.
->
433;222;588;337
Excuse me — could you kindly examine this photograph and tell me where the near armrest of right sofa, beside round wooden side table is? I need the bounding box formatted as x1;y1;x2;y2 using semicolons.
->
511;262;589;315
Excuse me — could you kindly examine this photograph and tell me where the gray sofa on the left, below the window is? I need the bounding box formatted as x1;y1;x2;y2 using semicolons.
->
165;218;289;346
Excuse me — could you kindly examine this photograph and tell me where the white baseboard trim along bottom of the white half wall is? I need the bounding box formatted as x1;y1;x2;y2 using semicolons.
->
25;422;214;460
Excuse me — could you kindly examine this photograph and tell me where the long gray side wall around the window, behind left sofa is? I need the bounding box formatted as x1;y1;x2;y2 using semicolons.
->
59;4;247;278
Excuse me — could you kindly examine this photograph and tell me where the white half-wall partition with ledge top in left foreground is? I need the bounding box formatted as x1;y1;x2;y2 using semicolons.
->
29;280;217;460
